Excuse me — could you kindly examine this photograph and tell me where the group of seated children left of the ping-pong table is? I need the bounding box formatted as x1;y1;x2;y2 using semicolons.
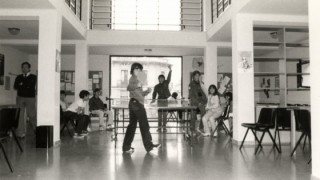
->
60;89;113;138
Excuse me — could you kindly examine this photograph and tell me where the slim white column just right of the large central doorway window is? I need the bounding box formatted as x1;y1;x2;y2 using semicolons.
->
204;42;218;87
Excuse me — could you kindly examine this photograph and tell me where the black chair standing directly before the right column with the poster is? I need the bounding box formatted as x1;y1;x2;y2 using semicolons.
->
239;108;281;154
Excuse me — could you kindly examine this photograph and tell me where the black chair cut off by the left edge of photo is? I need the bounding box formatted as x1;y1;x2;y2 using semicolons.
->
0;108;23;172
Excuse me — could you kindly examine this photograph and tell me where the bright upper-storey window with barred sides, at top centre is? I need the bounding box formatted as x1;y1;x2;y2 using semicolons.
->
91;0;202;31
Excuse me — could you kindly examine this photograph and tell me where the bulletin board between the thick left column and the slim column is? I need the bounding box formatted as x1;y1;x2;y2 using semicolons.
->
60;71;75;95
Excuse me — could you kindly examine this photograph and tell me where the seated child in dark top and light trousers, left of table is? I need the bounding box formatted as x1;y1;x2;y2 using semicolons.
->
89;88;113;131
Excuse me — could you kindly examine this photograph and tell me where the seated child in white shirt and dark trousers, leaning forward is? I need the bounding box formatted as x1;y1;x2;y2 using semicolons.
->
64;90;90;138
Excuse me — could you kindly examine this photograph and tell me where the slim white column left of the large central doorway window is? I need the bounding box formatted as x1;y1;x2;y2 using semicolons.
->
74;41;89;100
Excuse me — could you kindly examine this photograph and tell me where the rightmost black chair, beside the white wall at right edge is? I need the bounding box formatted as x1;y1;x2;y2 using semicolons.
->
291;110;311;156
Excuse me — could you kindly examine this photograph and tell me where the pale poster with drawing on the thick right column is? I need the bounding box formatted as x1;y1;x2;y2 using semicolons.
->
238;51;253;73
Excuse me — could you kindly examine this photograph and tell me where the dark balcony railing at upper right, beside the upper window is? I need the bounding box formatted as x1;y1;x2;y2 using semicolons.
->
211;0;231;24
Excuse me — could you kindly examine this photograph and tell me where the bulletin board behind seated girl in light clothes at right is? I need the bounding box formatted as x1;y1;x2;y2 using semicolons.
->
217;73;232;96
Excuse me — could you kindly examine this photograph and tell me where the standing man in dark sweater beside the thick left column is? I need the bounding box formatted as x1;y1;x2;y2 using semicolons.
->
14;62;37;138
